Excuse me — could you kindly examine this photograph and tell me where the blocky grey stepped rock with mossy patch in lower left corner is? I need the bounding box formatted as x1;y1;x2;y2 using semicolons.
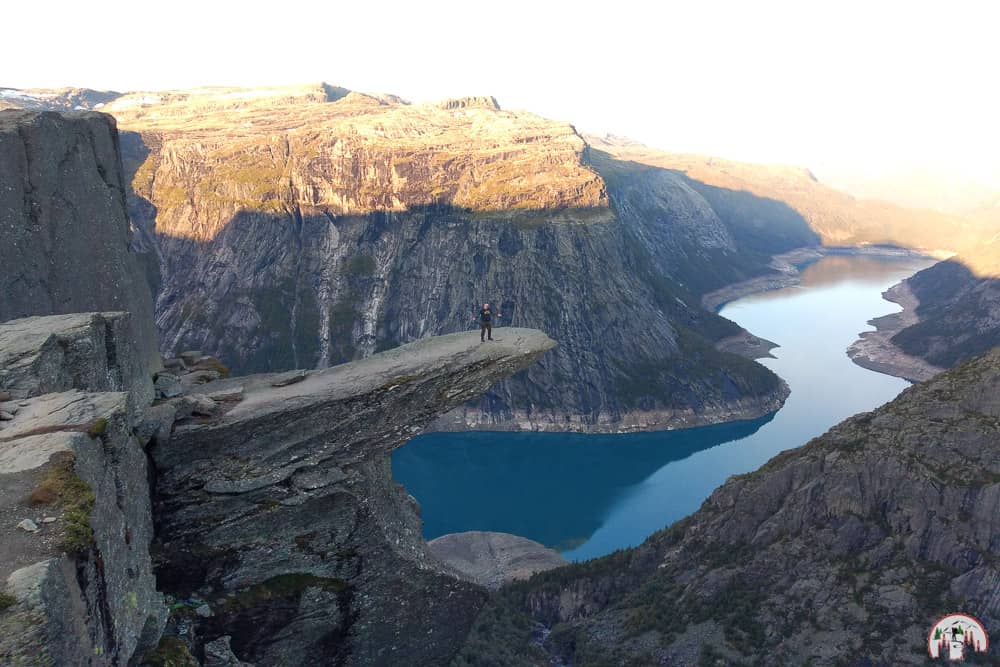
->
0;313;166;665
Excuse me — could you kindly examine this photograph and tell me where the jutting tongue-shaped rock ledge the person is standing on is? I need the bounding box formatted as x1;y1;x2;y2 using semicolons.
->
151;328;554;667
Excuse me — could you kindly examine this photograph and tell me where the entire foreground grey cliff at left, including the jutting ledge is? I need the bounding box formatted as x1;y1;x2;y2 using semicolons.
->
0;107;554;666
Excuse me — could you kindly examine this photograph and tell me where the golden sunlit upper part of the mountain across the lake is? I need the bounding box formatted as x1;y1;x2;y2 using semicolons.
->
101;84;608;220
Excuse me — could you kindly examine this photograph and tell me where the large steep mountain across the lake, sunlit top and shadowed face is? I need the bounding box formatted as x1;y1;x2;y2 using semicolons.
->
97;88;788;430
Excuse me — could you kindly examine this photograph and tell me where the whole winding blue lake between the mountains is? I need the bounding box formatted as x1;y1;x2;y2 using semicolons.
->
392;256;929;560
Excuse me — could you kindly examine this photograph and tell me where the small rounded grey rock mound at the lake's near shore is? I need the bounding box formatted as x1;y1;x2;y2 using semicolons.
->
427;530;569;590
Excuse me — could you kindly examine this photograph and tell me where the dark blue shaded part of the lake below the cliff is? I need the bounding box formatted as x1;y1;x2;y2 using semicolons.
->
393;417;771;548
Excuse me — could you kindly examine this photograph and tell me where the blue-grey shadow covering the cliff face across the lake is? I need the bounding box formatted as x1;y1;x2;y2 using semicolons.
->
122;132;868;422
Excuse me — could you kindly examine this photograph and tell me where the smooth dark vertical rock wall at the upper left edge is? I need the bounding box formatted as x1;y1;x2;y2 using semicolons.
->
0;111;159;392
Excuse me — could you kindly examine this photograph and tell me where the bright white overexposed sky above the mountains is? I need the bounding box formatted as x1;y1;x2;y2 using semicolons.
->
0;0;1000;189
